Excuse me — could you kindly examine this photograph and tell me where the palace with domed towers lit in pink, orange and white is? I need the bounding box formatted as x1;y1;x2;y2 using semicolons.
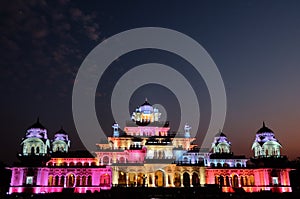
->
9;100;292;193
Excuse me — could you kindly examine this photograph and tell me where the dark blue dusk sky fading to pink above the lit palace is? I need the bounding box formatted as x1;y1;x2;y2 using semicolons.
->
0;0;300;163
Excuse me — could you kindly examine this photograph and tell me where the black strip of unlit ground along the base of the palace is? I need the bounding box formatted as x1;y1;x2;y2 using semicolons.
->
0;187;300;199
